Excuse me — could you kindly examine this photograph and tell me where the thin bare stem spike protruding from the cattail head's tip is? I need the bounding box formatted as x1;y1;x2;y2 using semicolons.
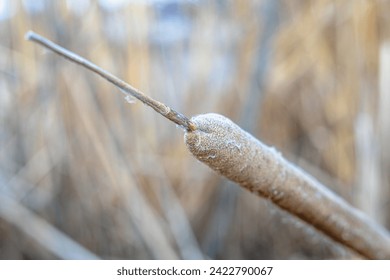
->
25;31;196;132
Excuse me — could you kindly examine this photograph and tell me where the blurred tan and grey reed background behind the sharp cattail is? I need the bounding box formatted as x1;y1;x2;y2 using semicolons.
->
0;0;390;259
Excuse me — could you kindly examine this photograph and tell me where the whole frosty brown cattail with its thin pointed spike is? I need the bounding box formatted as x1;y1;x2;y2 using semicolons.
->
26;31;390;259
